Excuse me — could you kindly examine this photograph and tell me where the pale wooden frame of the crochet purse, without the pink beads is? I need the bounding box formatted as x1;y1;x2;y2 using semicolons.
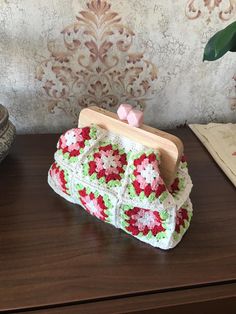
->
78;106;183;186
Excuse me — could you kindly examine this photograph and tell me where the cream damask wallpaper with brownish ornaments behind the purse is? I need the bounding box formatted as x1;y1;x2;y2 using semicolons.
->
0;0;236;133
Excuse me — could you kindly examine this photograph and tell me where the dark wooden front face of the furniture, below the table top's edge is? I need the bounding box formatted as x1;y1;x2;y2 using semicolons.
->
23;284;236;314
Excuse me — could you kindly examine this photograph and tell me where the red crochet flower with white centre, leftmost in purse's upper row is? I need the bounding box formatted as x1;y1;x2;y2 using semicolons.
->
57;127;91;157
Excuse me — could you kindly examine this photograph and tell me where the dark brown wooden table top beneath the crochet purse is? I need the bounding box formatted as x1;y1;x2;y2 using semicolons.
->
0;128;236;313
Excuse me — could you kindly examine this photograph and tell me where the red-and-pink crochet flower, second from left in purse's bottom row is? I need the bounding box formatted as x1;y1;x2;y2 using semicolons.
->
79;189;108;220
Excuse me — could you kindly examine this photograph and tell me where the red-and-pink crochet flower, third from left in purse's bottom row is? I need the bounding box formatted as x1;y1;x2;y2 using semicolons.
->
125;207;165;236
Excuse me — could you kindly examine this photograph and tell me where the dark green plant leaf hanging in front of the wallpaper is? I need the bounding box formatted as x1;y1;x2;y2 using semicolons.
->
203;21;236;61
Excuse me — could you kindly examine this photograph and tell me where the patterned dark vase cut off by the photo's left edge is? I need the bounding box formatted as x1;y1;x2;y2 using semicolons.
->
0;105;16;161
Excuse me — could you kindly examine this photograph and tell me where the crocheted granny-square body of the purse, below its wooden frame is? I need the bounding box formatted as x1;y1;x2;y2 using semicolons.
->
48;125;192;249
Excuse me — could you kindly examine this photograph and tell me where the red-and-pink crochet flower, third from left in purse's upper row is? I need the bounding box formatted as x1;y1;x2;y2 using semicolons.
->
133;153;166;197
